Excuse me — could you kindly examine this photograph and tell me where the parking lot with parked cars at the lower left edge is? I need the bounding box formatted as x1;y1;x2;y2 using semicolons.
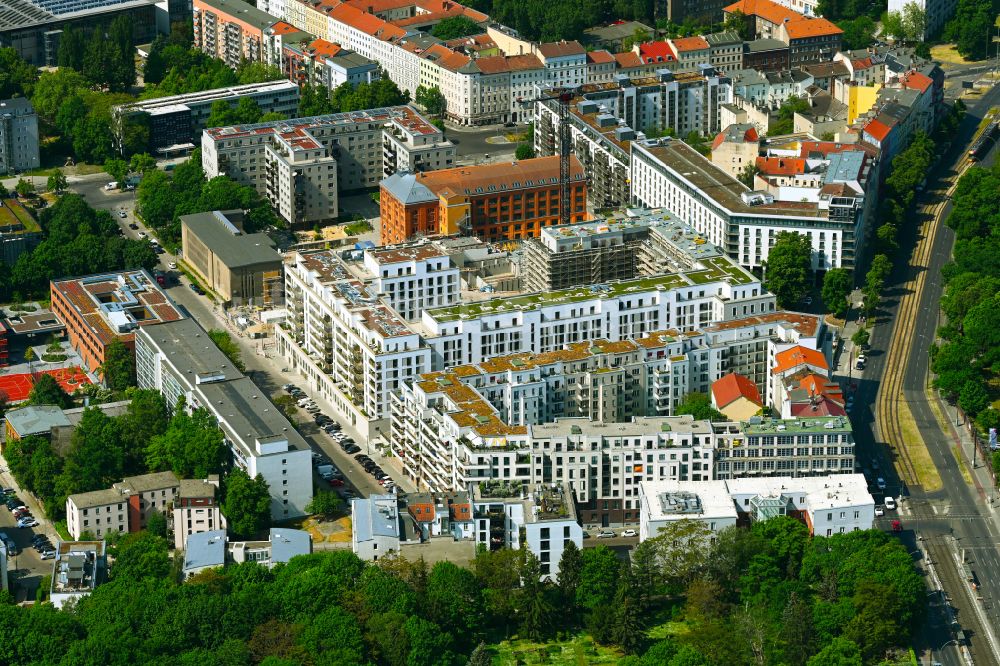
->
0;473;59;601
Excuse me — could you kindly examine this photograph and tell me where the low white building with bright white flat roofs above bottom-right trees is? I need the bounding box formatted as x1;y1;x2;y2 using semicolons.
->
639;474;875;541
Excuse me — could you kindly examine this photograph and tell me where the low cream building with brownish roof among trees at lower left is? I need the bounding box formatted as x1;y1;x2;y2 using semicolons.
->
66;472;180;539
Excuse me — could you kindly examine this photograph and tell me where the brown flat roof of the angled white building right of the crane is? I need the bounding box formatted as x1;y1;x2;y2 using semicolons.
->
636;139;826;218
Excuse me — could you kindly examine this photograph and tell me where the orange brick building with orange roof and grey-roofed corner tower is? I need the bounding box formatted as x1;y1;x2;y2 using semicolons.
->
379;156;587;245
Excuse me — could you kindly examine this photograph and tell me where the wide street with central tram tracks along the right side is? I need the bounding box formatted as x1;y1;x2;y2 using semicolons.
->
852;87;1000;665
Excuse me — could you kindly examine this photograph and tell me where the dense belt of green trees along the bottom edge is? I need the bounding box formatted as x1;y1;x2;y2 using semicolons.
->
0;517;925;666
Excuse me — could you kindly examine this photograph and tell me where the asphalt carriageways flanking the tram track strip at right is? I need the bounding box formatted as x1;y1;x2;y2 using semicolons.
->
853;88;1000;666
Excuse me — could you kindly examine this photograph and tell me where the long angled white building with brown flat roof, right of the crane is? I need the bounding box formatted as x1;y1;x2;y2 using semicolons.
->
631;139;870;271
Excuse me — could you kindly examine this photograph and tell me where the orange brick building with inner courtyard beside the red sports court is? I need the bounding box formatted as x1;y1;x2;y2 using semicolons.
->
49;270;184;372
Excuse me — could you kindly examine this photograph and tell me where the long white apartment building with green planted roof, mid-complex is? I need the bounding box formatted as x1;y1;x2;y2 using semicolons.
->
419;229;775;370
